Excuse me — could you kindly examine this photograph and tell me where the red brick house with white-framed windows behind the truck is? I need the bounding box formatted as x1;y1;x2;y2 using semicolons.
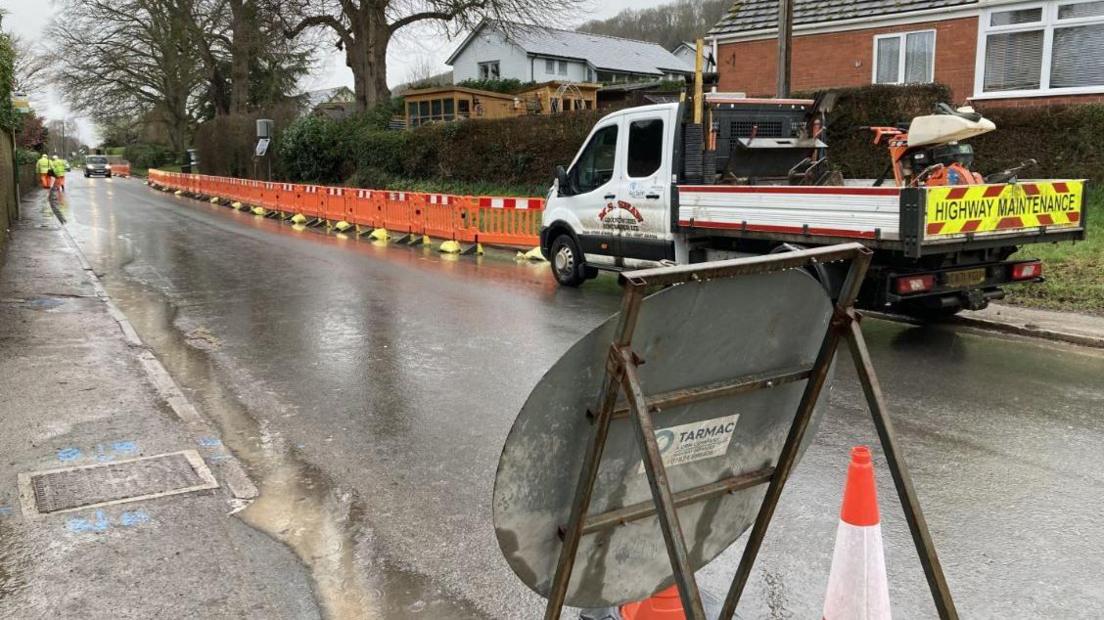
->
708;0;1104;106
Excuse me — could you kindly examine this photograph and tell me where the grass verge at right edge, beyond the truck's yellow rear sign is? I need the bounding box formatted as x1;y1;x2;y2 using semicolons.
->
1006;188;1104;316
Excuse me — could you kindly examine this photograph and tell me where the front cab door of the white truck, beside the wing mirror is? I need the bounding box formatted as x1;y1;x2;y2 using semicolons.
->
558;117;622;263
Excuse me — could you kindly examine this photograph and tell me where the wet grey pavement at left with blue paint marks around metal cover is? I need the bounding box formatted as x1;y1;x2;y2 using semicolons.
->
0;193;319;618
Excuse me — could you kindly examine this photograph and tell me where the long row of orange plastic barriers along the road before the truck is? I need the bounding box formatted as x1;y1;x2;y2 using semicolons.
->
149;170;544;248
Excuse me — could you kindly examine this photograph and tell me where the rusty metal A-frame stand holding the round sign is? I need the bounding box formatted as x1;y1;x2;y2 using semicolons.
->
544;244;958;620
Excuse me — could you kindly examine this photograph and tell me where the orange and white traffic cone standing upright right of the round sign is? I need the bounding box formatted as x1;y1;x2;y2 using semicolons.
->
824;446;890;620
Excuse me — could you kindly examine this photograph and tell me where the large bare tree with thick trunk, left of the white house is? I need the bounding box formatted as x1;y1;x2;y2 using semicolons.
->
276;0;582;110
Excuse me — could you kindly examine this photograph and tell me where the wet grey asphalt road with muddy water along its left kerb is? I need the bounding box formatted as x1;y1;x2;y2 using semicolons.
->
56;178;1104;618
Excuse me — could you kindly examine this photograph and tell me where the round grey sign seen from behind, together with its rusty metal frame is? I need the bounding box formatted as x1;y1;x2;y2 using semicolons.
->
493;244;957;620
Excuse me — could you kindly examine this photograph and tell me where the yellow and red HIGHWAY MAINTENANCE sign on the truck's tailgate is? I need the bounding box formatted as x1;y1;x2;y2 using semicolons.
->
925;181;1084;237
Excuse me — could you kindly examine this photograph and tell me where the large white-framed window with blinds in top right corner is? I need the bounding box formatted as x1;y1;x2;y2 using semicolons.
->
975;0;1104;97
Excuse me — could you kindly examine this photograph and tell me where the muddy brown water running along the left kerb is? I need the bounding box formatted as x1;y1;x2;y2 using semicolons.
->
105;280;485;619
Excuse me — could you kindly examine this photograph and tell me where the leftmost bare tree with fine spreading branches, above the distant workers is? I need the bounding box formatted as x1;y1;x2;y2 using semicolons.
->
47;0;202;150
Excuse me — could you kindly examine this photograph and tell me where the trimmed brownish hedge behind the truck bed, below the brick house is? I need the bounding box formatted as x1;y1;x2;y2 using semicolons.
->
805;84;1104;181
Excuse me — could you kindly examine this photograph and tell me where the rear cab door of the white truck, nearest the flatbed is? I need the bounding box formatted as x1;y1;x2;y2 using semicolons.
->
605;109;675;261
